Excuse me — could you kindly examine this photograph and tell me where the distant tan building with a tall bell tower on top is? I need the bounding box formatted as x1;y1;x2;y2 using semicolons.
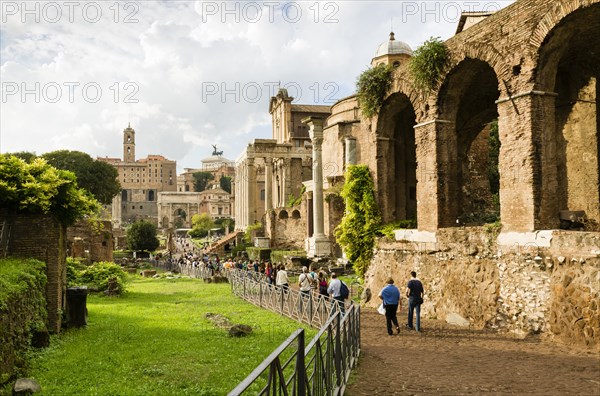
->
97;125;177;228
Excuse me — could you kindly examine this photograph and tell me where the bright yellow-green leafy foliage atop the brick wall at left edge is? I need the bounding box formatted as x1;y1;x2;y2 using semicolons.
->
0;154;100;225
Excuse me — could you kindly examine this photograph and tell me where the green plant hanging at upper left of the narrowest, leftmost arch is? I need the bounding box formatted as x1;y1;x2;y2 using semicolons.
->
356;65;394;118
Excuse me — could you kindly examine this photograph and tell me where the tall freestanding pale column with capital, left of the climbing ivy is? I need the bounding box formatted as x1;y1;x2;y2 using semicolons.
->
302;117;331;257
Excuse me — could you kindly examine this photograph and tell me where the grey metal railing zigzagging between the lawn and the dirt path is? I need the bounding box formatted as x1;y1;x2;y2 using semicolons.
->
228;270;360;396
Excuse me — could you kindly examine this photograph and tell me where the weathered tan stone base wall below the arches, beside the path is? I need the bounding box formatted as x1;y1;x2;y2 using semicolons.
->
365;227;600;347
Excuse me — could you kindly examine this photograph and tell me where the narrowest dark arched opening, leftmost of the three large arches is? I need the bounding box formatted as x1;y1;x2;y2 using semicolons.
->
377;92;417;223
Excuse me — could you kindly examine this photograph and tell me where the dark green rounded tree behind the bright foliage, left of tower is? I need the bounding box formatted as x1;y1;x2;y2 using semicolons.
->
42;150;121;205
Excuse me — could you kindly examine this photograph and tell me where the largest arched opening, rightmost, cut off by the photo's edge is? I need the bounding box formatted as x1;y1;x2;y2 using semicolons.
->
536;4;600;231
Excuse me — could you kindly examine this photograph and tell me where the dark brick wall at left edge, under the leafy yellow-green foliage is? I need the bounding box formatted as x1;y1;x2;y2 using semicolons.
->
0;211;67;332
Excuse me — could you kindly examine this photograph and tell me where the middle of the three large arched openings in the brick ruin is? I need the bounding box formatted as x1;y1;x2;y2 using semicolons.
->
438;58;500;226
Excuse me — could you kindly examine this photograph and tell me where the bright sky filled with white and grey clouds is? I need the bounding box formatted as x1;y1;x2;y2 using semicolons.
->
0;0;512;171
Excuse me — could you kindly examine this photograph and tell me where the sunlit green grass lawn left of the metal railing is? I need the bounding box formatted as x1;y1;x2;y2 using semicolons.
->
25;279;316;395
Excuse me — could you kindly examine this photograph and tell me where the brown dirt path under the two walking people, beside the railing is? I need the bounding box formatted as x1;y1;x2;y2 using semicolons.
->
346;308;600;396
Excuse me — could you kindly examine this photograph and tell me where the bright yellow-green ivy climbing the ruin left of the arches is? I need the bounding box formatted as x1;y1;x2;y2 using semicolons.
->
335;165;381;278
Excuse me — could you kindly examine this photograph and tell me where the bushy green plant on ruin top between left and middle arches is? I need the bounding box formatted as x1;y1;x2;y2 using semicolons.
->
408;37;449;93
